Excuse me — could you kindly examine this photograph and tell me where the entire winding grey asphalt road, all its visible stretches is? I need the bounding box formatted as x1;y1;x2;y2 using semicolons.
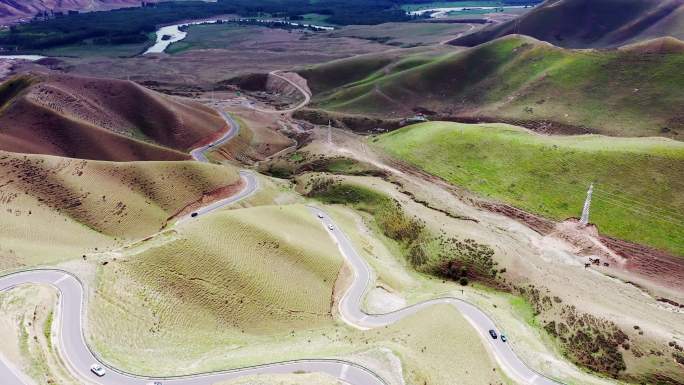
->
0;103;558;385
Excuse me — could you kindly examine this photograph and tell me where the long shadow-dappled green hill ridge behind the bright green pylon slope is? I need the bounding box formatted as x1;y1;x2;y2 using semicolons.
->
301;36;684;138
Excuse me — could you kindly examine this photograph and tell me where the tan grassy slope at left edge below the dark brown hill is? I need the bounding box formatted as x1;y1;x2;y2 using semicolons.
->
0;152;239;271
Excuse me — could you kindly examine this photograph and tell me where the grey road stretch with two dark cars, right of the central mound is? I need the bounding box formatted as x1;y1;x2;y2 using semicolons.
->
307;205;562;385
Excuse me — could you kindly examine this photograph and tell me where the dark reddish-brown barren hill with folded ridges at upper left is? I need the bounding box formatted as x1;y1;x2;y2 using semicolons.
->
0;73;226;161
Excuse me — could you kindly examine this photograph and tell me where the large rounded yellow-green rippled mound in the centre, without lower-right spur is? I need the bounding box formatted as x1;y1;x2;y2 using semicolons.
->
90;206;342;370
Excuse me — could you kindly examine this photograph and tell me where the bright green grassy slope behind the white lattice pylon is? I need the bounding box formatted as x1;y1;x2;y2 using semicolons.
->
376;122;684;256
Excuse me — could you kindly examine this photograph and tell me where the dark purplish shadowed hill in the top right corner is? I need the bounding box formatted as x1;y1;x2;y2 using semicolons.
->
452;0;684;48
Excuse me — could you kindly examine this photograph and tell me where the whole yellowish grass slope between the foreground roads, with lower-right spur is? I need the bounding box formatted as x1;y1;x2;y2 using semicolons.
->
87;205;507;385
